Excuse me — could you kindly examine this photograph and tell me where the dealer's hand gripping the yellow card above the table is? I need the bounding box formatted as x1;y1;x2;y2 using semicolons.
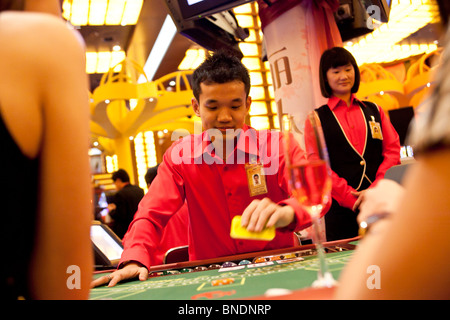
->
241;198;295;232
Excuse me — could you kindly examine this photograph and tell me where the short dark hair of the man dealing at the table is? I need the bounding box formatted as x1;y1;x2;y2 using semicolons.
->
192;50;250;101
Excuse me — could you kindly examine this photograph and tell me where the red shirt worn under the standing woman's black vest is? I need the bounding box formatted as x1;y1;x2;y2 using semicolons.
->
322;95;400;209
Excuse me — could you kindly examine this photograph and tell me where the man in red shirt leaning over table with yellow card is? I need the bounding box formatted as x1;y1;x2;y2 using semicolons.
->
94;52;326;286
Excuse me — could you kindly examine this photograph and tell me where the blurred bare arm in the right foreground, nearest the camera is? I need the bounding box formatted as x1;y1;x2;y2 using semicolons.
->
336;150;450;299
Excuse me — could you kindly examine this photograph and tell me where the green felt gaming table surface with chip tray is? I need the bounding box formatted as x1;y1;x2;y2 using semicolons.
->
90;238;357;300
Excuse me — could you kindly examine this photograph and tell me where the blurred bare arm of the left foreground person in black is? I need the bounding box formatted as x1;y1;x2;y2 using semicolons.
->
24;14;93;299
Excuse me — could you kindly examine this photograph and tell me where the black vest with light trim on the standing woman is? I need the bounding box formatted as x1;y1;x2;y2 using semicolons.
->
316;101;383;190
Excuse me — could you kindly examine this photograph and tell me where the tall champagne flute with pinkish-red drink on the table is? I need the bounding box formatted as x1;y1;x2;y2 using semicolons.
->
284;112;336;288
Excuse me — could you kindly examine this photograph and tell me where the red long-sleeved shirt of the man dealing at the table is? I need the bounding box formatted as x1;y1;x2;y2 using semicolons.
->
121;126;322;268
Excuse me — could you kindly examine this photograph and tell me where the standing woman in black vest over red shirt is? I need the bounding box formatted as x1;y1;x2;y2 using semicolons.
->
305;47;400;241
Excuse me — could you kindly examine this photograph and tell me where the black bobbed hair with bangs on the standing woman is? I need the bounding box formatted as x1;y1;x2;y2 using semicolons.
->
319;47;361;98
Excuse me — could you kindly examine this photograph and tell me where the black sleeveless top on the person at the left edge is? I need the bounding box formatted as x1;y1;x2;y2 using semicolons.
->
0;114;39;299
